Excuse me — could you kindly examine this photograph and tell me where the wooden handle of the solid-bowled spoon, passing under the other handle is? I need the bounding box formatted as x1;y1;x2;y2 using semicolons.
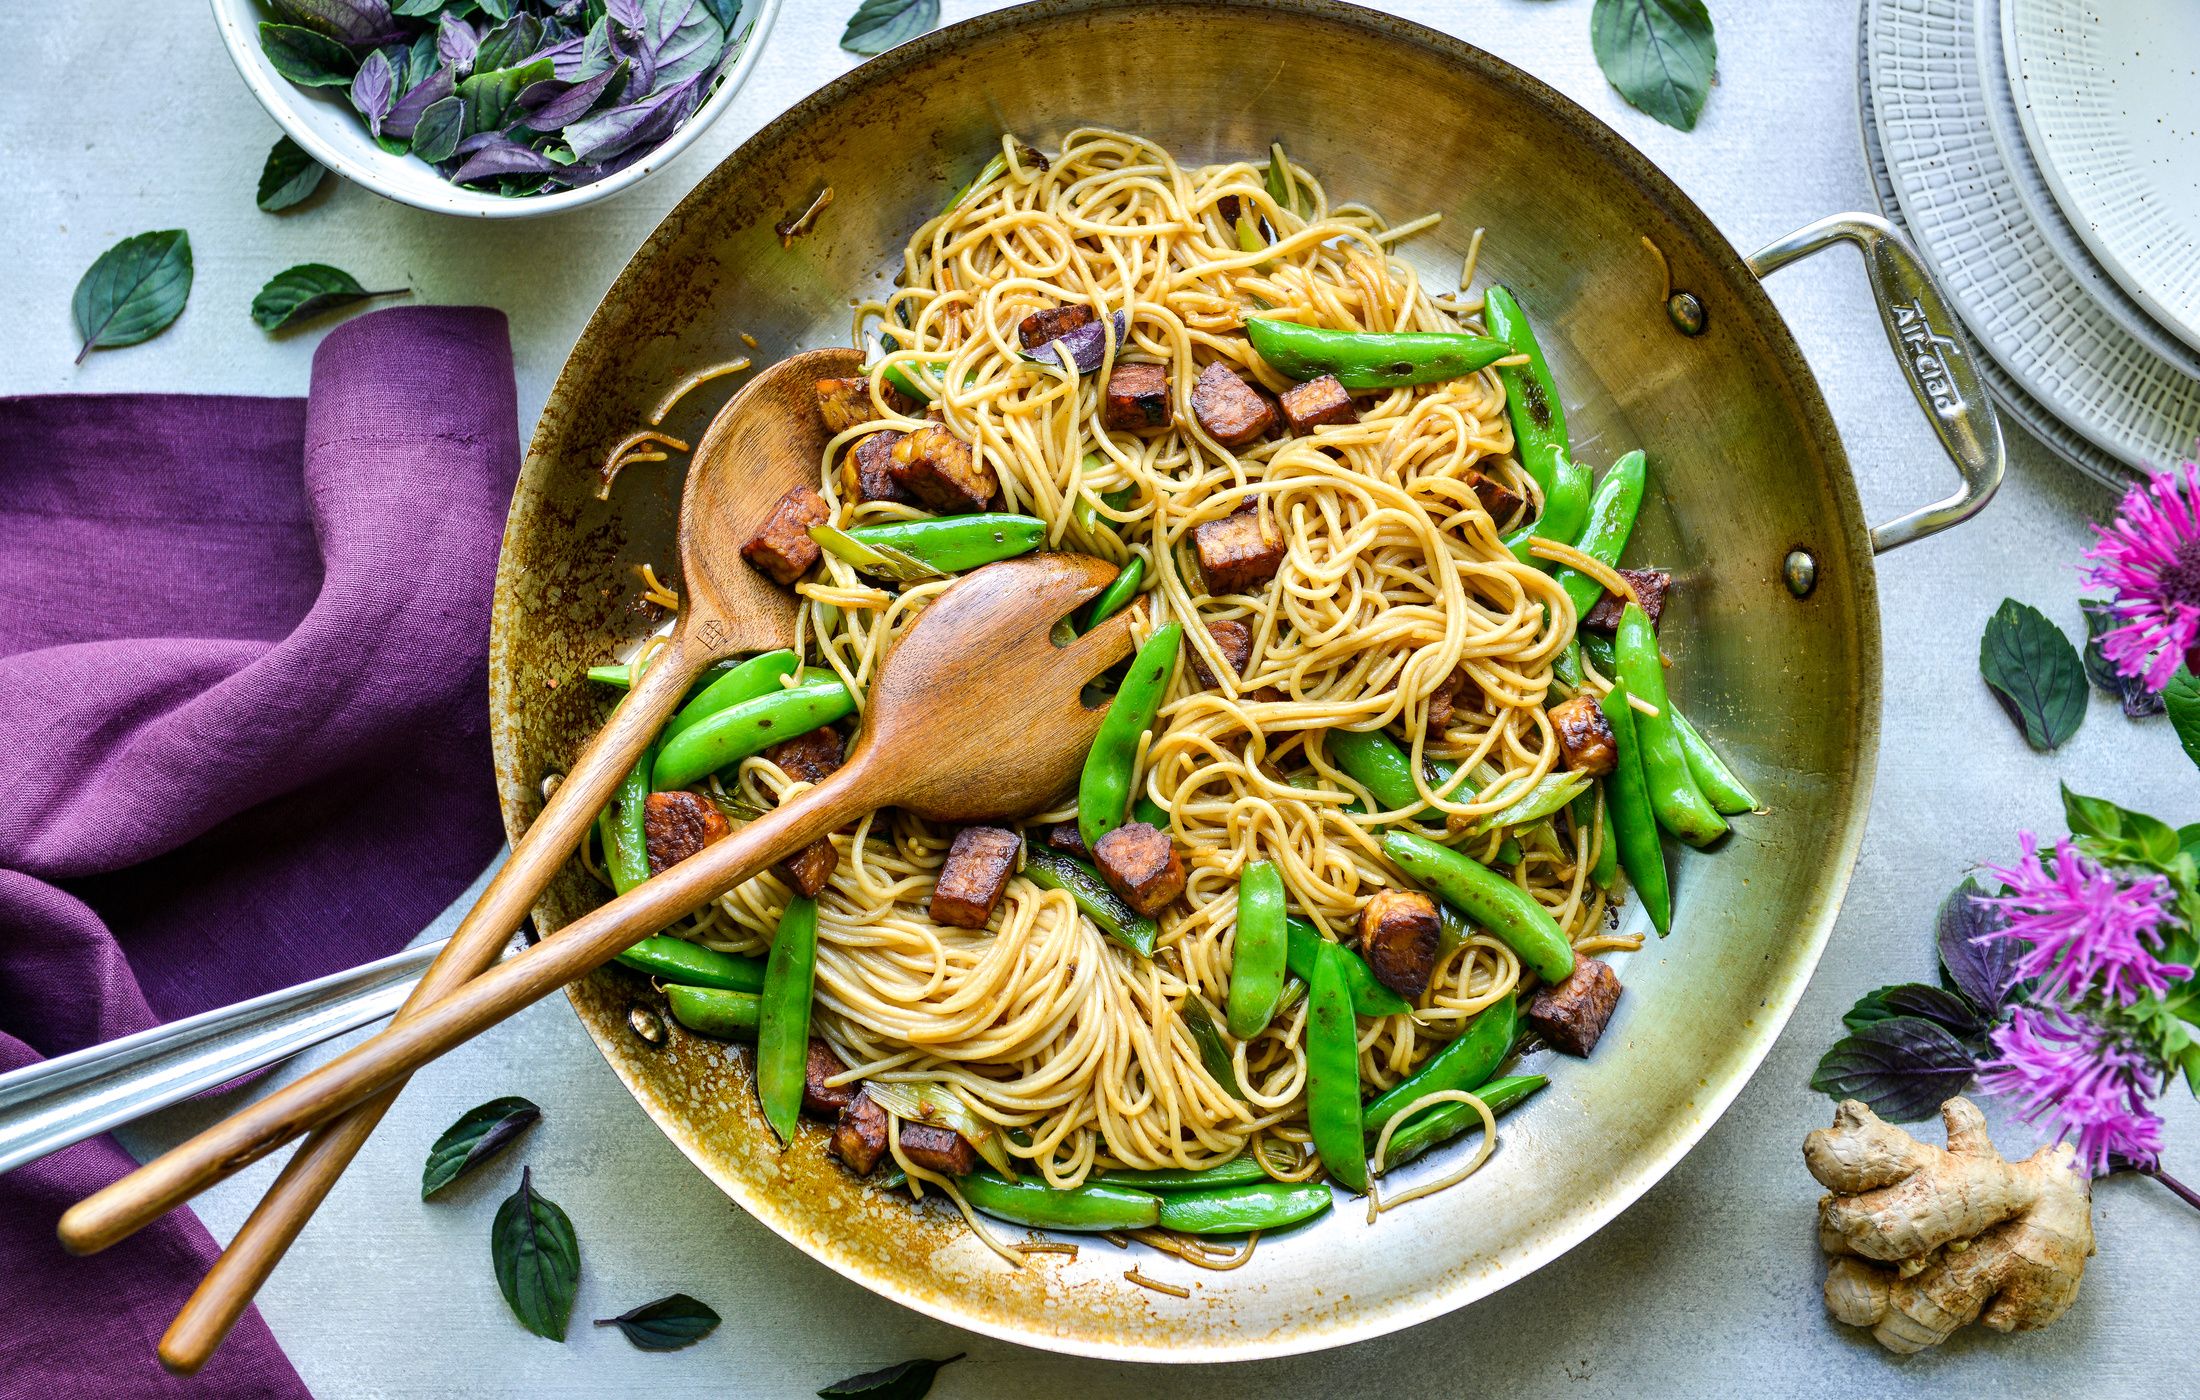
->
146;638;711;1376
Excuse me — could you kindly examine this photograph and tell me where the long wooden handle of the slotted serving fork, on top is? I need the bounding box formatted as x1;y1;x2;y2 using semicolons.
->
59;762;858;1255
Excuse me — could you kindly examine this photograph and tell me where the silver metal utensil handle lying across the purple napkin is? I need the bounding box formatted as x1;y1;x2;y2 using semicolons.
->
0;940;444;1171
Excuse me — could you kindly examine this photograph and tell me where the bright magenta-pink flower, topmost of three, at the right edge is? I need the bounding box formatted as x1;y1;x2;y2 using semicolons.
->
2081;462;2200;691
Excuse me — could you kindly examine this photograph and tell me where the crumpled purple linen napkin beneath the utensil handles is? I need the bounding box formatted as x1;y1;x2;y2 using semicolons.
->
0;306;519;1400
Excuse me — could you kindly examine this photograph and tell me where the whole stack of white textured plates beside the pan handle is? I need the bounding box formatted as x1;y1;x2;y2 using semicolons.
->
1859;0;2200;484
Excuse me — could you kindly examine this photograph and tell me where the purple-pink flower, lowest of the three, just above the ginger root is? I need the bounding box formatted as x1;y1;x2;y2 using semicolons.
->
1978;1006;2163;1175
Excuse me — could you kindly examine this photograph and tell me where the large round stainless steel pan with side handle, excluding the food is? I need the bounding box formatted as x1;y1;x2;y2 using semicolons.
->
491;0;2002;1360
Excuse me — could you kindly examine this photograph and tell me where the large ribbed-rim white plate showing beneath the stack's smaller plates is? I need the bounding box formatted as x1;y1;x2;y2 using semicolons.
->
1866;0;2200;467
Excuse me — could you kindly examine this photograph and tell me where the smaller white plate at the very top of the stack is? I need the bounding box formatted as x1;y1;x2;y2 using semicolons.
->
1989;0;2200;348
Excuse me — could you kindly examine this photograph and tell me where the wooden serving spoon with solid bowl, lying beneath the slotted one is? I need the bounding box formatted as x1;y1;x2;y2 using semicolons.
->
146;348;862;1376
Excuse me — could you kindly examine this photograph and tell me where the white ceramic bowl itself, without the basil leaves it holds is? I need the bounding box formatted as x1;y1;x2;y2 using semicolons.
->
213;0;779;218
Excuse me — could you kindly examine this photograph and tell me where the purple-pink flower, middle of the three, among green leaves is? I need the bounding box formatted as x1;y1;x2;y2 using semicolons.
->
1982;832;2193;1006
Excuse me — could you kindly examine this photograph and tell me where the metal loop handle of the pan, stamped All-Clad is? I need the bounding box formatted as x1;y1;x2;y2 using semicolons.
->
1749;214;2006;555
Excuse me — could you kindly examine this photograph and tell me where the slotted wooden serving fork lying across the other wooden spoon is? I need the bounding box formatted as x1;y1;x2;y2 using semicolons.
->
59;555;1137;1255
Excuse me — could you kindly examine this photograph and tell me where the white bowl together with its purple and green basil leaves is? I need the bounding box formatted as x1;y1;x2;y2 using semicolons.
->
213;0;781;218
